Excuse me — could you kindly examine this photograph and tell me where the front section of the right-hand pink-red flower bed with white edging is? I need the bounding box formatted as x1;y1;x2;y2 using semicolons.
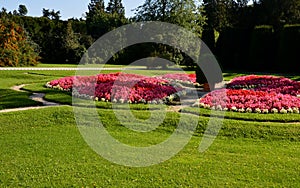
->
199;89;300;113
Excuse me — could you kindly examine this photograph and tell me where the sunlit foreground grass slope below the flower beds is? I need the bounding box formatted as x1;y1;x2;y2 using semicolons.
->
0;107;300;187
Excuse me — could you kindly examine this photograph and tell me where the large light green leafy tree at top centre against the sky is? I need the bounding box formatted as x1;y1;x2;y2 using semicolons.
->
134;0;206;66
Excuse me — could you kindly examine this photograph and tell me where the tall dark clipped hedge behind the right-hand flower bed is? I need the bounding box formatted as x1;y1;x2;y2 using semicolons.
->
216;25;300;73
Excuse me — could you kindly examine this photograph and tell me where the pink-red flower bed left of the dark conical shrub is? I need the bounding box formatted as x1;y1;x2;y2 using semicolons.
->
46;73;193;103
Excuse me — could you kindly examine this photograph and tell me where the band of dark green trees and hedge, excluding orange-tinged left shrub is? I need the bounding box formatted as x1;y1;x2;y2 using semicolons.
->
0;0;300;69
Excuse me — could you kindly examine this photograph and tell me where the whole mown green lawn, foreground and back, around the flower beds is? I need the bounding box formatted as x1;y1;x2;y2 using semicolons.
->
0;70;300;187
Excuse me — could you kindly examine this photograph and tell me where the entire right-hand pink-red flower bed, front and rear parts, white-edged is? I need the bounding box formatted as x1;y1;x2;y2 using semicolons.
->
195;75;300;113
